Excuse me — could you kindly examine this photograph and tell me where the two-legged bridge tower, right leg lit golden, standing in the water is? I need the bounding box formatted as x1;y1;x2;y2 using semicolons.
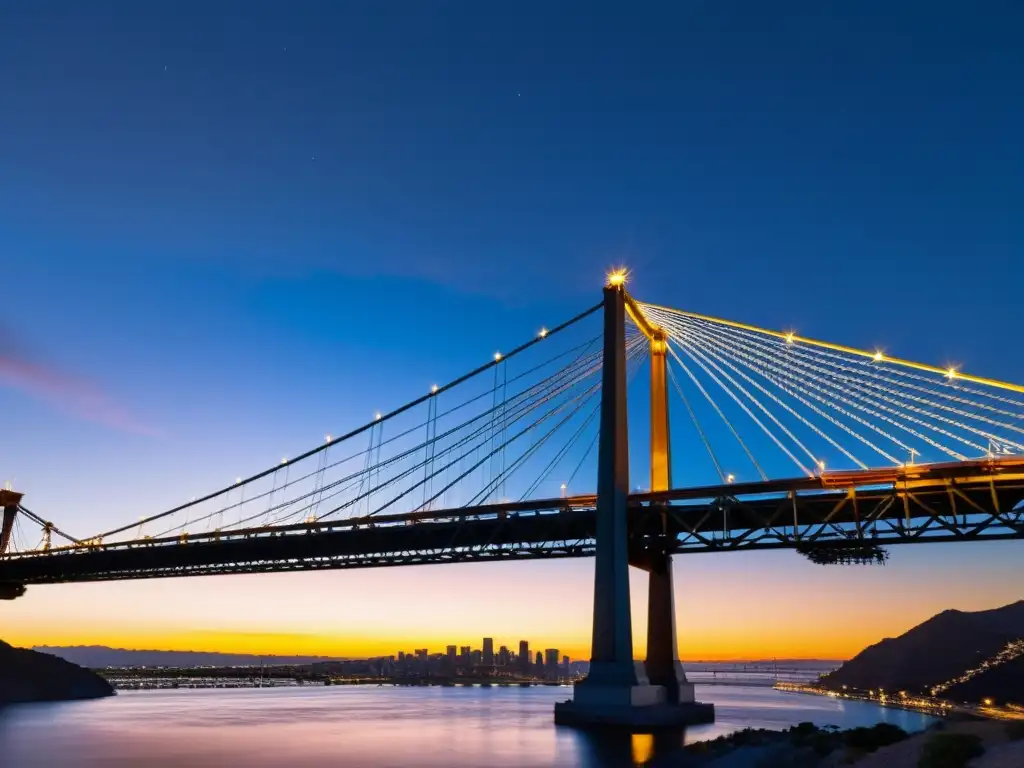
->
555;273;714;728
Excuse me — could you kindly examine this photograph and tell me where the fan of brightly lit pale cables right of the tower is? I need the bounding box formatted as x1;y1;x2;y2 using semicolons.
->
639;303;1024;482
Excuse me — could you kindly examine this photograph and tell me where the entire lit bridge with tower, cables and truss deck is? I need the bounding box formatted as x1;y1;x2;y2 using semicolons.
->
0;272;1024;724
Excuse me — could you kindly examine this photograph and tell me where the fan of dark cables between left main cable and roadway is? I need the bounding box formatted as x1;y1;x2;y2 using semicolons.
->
41;305;647;544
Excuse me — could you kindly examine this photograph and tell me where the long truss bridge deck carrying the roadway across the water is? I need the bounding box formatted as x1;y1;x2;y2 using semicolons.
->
0;458;1024;597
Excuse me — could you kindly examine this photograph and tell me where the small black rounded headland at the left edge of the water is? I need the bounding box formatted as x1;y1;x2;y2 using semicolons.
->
0;642;114;708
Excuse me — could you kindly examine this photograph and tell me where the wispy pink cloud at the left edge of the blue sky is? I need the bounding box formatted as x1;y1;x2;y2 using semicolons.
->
0;328;158;435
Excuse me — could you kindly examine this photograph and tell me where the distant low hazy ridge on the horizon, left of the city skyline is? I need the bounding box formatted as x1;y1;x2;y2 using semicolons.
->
33;645;344;670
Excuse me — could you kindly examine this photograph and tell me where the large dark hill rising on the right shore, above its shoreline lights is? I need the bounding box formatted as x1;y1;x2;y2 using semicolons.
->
821;600;1024;700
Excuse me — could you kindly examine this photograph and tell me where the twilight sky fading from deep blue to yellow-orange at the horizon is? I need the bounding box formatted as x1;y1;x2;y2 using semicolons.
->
0;0;1024;658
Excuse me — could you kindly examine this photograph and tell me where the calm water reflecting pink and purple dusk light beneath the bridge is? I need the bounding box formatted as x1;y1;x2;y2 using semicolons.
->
0;685;929;768
